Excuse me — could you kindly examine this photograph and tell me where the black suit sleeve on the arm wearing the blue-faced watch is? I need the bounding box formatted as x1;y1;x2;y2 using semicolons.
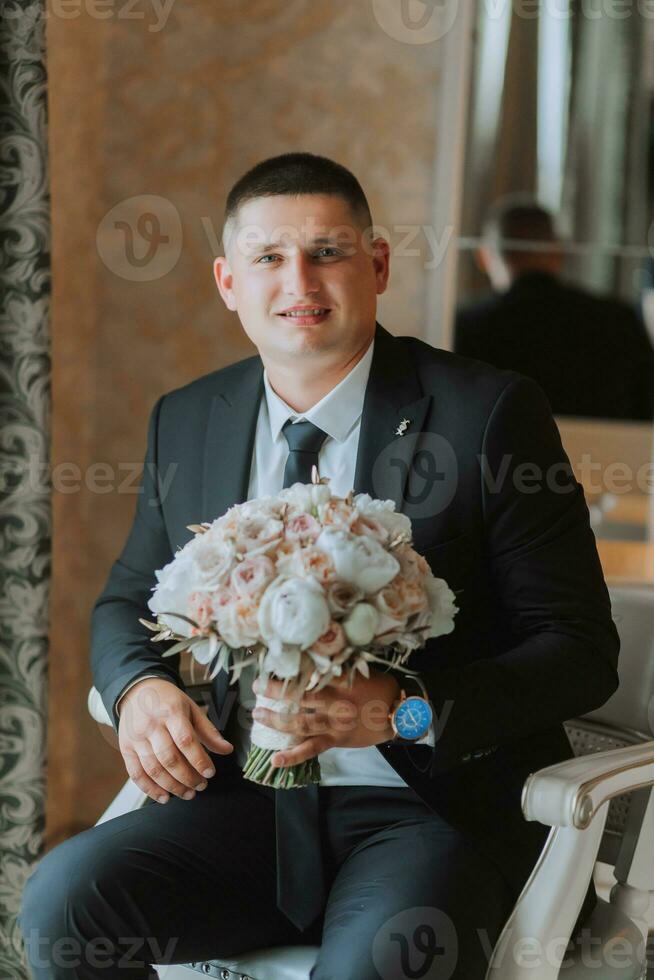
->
410;378;619;775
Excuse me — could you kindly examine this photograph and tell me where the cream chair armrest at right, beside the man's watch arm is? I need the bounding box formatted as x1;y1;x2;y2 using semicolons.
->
522;741;654;830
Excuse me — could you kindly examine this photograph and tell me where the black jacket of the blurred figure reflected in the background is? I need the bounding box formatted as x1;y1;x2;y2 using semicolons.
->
454;272;654;421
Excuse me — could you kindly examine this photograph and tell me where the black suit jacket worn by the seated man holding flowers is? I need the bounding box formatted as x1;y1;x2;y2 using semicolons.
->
92;325;619;916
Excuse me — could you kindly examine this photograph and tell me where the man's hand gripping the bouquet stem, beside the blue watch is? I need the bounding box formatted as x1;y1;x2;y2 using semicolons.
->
252;669;400;767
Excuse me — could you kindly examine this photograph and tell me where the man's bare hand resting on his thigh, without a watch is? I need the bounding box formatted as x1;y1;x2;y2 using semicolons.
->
118;677;234;803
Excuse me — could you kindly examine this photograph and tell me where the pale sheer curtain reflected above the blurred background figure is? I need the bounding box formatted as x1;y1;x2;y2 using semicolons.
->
458;0;654;303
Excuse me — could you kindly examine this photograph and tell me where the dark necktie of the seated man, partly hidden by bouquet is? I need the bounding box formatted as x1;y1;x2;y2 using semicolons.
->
275;419;327;930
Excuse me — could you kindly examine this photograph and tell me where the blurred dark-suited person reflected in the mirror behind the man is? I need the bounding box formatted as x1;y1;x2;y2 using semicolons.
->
454;198;654;420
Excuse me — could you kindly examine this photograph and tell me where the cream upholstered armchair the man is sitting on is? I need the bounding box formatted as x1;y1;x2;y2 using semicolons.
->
89;589;654;980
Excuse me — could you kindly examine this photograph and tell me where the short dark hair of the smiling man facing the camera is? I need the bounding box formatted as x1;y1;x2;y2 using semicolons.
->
225;153;372;241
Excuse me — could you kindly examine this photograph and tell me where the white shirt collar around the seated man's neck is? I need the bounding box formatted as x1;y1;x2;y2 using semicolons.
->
263;338;375;442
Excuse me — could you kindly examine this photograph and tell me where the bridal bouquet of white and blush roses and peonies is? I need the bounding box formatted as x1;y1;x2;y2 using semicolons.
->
141;467;457;788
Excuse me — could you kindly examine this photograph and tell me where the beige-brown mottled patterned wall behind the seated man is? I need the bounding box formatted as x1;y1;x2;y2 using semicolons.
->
48;0;440;844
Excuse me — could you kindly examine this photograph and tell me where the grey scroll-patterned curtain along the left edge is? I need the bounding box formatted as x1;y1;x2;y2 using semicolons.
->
0;0;51;980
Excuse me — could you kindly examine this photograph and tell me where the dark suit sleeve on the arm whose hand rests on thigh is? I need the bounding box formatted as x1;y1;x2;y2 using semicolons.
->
91;396;186;731
